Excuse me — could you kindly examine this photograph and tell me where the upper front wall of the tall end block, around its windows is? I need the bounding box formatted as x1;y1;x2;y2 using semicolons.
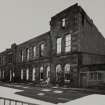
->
50;6;79;56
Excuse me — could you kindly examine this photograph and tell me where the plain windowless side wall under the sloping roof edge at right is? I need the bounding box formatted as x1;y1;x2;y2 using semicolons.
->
79;11;105;55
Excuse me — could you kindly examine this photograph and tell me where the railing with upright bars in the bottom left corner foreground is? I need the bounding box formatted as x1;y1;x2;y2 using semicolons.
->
0;97;37;105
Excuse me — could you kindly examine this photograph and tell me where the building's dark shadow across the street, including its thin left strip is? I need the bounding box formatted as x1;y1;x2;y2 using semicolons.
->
0;83;96;104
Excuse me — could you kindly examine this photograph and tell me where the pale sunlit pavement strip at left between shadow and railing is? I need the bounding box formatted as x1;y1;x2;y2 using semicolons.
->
0;86;53;105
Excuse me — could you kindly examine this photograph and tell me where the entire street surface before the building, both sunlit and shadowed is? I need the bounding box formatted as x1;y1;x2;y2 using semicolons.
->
0;83;105;105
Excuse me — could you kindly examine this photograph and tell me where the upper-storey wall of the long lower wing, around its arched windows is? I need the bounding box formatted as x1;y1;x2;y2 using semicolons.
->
16;32;51;62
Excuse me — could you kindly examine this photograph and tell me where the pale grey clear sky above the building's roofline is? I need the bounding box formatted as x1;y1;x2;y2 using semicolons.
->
0;0;105;52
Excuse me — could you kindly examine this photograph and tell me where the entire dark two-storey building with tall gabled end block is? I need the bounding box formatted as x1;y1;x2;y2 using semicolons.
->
0;4;105;87
